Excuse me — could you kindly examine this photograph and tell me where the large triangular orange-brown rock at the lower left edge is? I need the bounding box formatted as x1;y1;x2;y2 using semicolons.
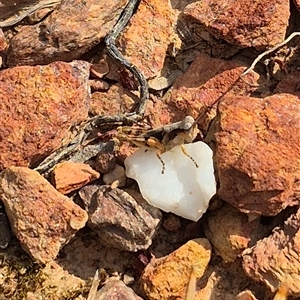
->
0;167;88;263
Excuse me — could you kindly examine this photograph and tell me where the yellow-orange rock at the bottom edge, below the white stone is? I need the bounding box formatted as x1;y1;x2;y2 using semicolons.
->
141;238;211;300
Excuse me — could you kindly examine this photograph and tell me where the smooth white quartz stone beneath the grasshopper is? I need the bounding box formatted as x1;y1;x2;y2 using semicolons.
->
125;142;216;221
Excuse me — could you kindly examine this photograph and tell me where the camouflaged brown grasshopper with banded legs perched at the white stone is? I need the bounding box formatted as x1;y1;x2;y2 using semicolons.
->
116;116;199;174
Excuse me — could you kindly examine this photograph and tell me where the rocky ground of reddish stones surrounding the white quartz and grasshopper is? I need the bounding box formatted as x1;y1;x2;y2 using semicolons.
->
0;0;300;300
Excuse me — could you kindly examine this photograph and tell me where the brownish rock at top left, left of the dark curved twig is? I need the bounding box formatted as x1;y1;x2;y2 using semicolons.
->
7;0;126;66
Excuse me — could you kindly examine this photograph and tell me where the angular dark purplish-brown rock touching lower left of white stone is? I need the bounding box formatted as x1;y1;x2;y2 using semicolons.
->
79;185;162;251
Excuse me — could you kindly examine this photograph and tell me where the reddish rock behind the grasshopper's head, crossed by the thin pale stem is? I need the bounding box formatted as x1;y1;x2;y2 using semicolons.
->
163;54;258;123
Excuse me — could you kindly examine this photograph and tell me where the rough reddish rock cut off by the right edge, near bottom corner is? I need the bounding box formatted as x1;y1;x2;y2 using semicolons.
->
243;209;300;299
